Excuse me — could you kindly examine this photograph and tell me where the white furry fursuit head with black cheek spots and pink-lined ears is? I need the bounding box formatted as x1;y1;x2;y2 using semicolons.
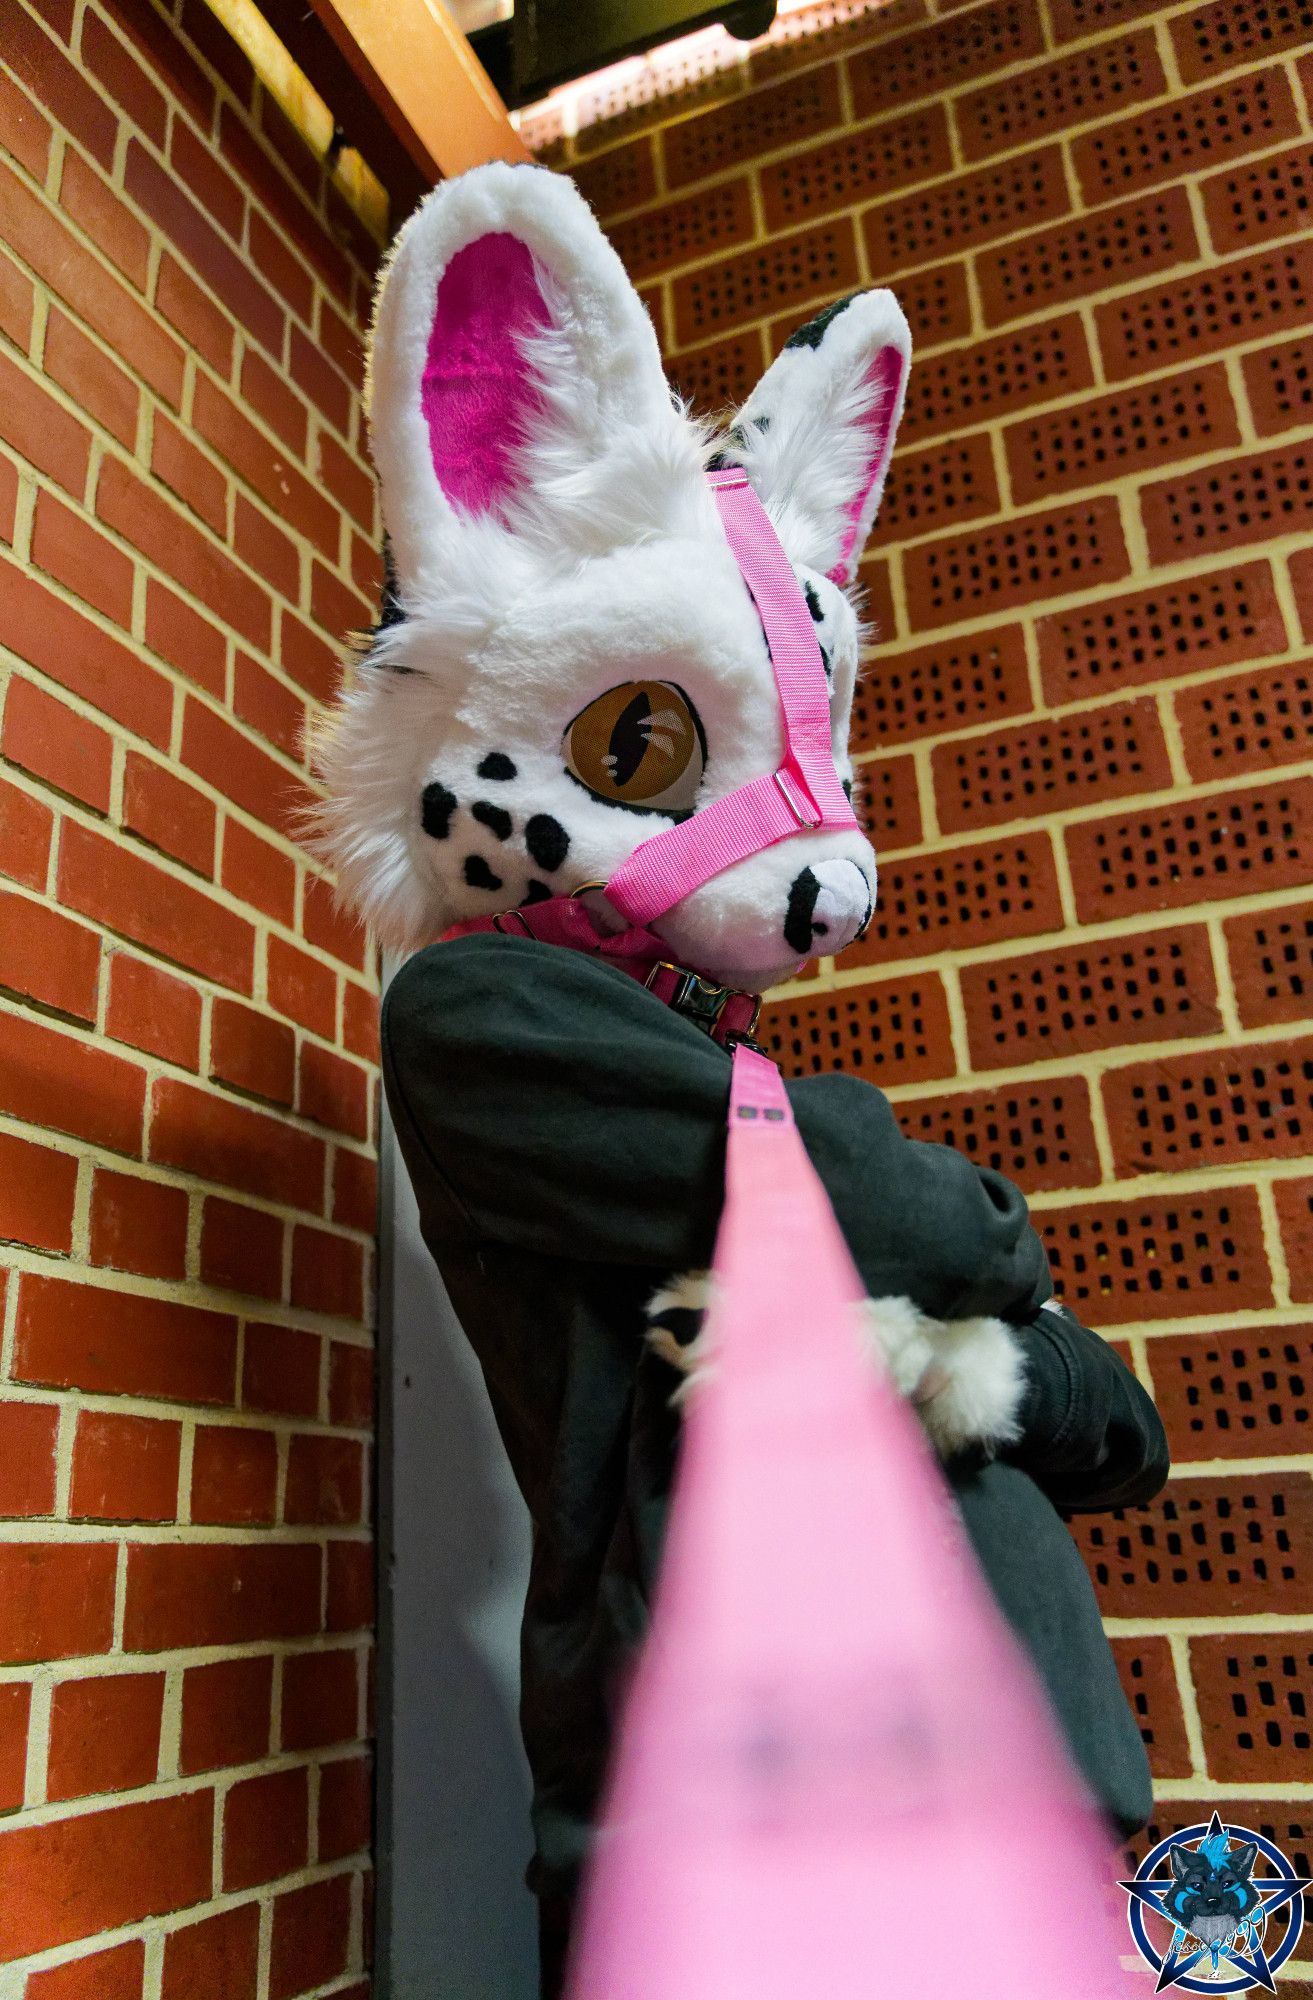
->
316;164;911;992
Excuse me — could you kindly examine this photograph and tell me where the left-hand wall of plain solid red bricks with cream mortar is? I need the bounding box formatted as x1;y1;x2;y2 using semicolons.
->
0;0;376;2000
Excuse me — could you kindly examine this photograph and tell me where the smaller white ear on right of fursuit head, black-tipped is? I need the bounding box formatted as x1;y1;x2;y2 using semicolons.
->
725;292;913;584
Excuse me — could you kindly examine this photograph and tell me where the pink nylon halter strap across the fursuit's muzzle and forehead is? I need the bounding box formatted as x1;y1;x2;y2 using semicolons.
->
606;470;859;924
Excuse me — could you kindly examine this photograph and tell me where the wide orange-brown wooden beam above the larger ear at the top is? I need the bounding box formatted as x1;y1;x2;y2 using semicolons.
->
310;0;530;182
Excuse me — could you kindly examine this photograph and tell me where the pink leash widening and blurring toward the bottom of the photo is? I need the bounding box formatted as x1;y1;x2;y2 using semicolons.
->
568;1046;1139;2000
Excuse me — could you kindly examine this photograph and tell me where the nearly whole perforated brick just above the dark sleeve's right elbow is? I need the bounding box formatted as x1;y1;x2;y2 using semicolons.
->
1033;1188;1273;1328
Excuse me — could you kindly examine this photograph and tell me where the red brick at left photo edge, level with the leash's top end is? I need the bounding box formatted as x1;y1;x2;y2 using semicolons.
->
0;1012;146;1154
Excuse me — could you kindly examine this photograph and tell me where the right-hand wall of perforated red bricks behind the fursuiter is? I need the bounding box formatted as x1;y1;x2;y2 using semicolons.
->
534;0;1313;1912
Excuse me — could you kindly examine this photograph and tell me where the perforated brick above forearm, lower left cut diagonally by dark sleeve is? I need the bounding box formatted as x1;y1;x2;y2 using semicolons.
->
897;1076;1099;1194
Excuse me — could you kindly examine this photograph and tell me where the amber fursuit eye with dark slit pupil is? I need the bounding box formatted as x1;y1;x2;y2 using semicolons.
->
564;680;707;812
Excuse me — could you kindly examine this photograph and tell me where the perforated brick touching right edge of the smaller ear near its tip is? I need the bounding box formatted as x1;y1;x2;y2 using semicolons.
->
899;312;1095;442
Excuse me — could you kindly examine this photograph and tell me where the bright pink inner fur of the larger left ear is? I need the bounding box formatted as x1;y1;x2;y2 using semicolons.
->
420;232;548;514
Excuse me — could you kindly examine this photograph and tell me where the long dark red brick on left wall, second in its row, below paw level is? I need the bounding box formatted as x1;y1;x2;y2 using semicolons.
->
124;1542;320;1652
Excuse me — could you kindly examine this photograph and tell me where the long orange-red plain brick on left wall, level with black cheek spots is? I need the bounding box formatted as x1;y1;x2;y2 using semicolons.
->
60;822;254;992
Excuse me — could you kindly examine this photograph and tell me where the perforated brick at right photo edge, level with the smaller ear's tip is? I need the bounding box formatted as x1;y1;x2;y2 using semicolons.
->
1095;244;1313;382
